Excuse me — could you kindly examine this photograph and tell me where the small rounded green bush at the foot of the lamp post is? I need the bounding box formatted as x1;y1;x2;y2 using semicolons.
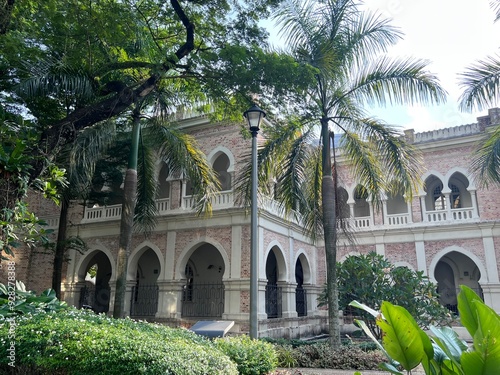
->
215;336;277;375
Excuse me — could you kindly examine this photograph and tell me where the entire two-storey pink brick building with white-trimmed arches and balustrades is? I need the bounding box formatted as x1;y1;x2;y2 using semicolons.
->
3;109;500;337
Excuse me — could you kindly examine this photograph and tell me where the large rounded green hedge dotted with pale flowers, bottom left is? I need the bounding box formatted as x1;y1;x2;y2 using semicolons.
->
0;309;237;375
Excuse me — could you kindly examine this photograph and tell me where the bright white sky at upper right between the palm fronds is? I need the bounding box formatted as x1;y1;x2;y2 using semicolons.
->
271;0;500;133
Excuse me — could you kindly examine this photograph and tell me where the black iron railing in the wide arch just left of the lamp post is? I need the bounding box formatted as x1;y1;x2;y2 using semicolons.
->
181;283;225;318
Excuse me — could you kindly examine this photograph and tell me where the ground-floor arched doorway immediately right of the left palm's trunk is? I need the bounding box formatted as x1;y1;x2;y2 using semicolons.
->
130;248;161;318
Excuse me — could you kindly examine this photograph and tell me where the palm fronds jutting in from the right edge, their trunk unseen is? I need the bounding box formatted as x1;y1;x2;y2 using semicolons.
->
459;0;500;185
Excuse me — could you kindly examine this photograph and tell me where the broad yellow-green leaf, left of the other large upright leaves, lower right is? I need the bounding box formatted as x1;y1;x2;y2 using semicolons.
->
377;301;426;371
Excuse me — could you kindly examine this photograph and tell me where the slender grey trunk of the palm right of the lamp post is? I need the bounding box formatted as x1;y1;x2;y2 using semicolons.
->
321;118;341;348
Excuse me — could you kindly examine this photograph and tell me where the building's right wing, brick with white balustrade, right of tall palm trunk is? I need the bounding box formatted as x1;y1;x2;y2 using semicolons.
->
339;108;500;312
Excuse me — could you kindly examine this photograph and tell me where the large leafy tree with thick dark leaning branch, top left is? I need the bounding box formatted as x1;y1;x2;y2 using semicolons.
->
0;0;284;189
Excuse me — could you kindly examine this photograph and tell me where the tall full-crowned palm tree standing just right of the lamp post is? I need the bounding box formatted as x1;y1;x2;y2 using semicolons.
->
259;0;445;347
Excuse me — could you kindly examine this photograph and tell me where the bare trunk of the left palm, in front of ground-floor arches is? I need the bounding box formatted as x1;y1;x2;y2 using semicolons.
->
113;111;140;318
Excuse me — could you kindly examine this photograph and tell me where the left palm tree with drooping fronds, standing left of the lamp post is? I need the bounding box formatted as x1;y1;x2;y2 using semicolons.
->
113;107;219;318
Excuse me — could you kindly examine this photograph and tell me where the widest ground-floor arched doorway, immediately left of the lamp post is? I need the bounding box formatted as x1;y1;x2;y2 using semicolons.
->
182;243;225;318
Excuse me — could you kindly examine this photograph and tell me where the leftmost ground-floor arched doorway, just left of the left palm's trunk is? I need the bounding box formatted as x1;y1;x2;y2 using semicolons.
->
79;250;111;313
